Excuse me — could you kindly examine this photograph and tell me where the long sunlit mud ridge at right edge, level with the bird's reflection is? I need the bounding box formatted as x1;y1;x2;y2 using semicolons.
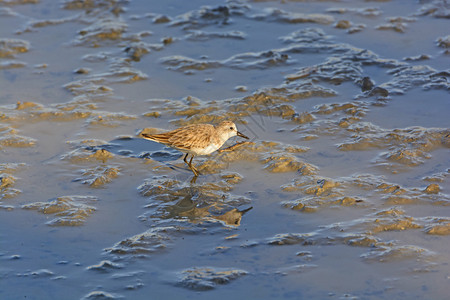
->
282;174;450;212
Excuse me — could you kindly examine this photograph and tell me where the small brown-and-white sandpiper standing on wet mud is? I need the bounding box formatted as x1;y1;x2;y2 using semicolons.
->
142;121;248;177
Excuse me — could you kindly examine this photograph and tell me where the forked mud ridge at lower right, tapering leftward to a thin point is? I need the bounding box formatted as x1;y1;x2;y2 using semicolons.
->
258;208;444;264
